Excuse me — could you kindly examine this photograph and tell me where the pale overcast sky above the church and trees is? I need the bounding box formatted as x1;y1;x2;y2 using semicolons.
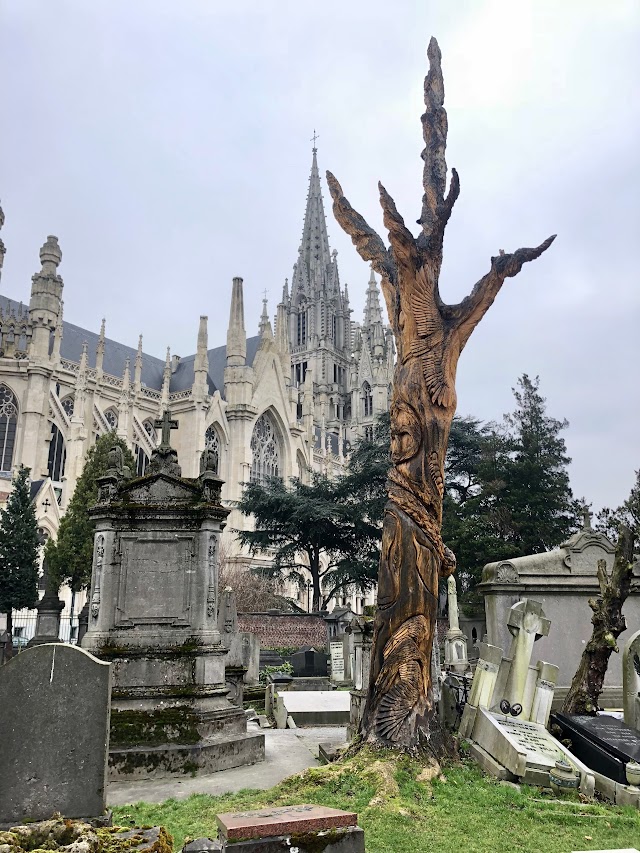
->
0;0;640;509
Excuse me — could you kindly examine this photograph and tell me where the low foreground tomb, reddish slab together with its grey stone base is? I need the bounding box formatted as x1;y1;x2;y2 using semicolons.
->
216;805;365;853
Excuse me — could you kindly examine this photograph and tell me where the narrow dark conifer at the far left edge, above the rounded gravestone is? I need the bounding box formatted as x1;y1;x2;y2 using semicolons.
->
0;466;40;641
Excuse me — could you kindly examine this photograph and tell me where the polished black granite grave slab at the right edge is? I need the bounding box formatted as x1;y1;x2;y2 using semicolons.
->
550;713;640;785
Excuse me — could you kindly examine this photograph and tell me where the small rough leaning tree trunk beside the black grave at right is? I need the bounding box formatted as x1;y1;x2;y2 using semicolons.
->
562;526;633;716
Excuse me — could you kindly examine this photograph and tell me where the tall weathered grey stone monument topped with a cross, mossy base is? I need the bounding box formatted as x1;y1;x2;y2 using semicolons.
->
82;412;264;778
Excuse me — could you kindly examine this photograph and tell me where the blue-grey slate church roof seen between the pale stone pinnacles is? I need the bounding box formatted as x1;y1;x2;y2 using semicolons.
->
0;295;260;394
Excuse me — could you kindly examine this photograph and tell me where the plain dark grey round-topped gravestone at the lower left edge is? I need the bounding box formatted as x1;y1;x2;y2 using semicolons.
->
0;644;111;825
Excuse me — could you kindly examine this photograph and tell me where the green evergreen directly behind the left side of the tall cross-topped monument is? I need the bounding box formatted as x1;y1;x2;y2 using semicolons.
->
45;432;136;592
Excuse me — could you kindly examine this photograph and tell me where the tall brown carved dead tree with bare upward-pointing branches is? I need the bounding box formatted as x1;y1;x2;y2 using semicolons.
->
327;39;554;749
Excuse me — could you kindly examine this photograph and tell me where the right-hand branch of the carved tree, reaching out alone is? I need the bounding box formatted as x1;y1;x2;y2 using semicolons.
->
450;234;556;350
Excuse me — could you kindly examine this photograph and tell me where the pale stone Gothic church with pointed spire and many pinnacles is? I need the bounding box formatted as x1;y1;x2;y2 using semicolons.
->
0;149;394;612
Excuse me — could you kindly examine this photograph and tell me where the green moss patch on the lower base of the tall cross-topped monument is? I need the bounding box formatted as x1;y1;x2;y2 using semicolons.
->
111;705;201;747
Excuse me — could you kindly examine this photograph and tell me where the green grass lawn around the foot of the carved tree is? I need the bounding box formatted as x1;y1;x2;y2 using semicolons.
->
114;751;640;853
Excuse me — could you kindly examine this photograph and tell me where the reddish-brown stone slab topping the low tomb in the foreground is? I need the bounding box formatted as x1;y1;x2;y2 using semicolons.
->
216;804;358;841
